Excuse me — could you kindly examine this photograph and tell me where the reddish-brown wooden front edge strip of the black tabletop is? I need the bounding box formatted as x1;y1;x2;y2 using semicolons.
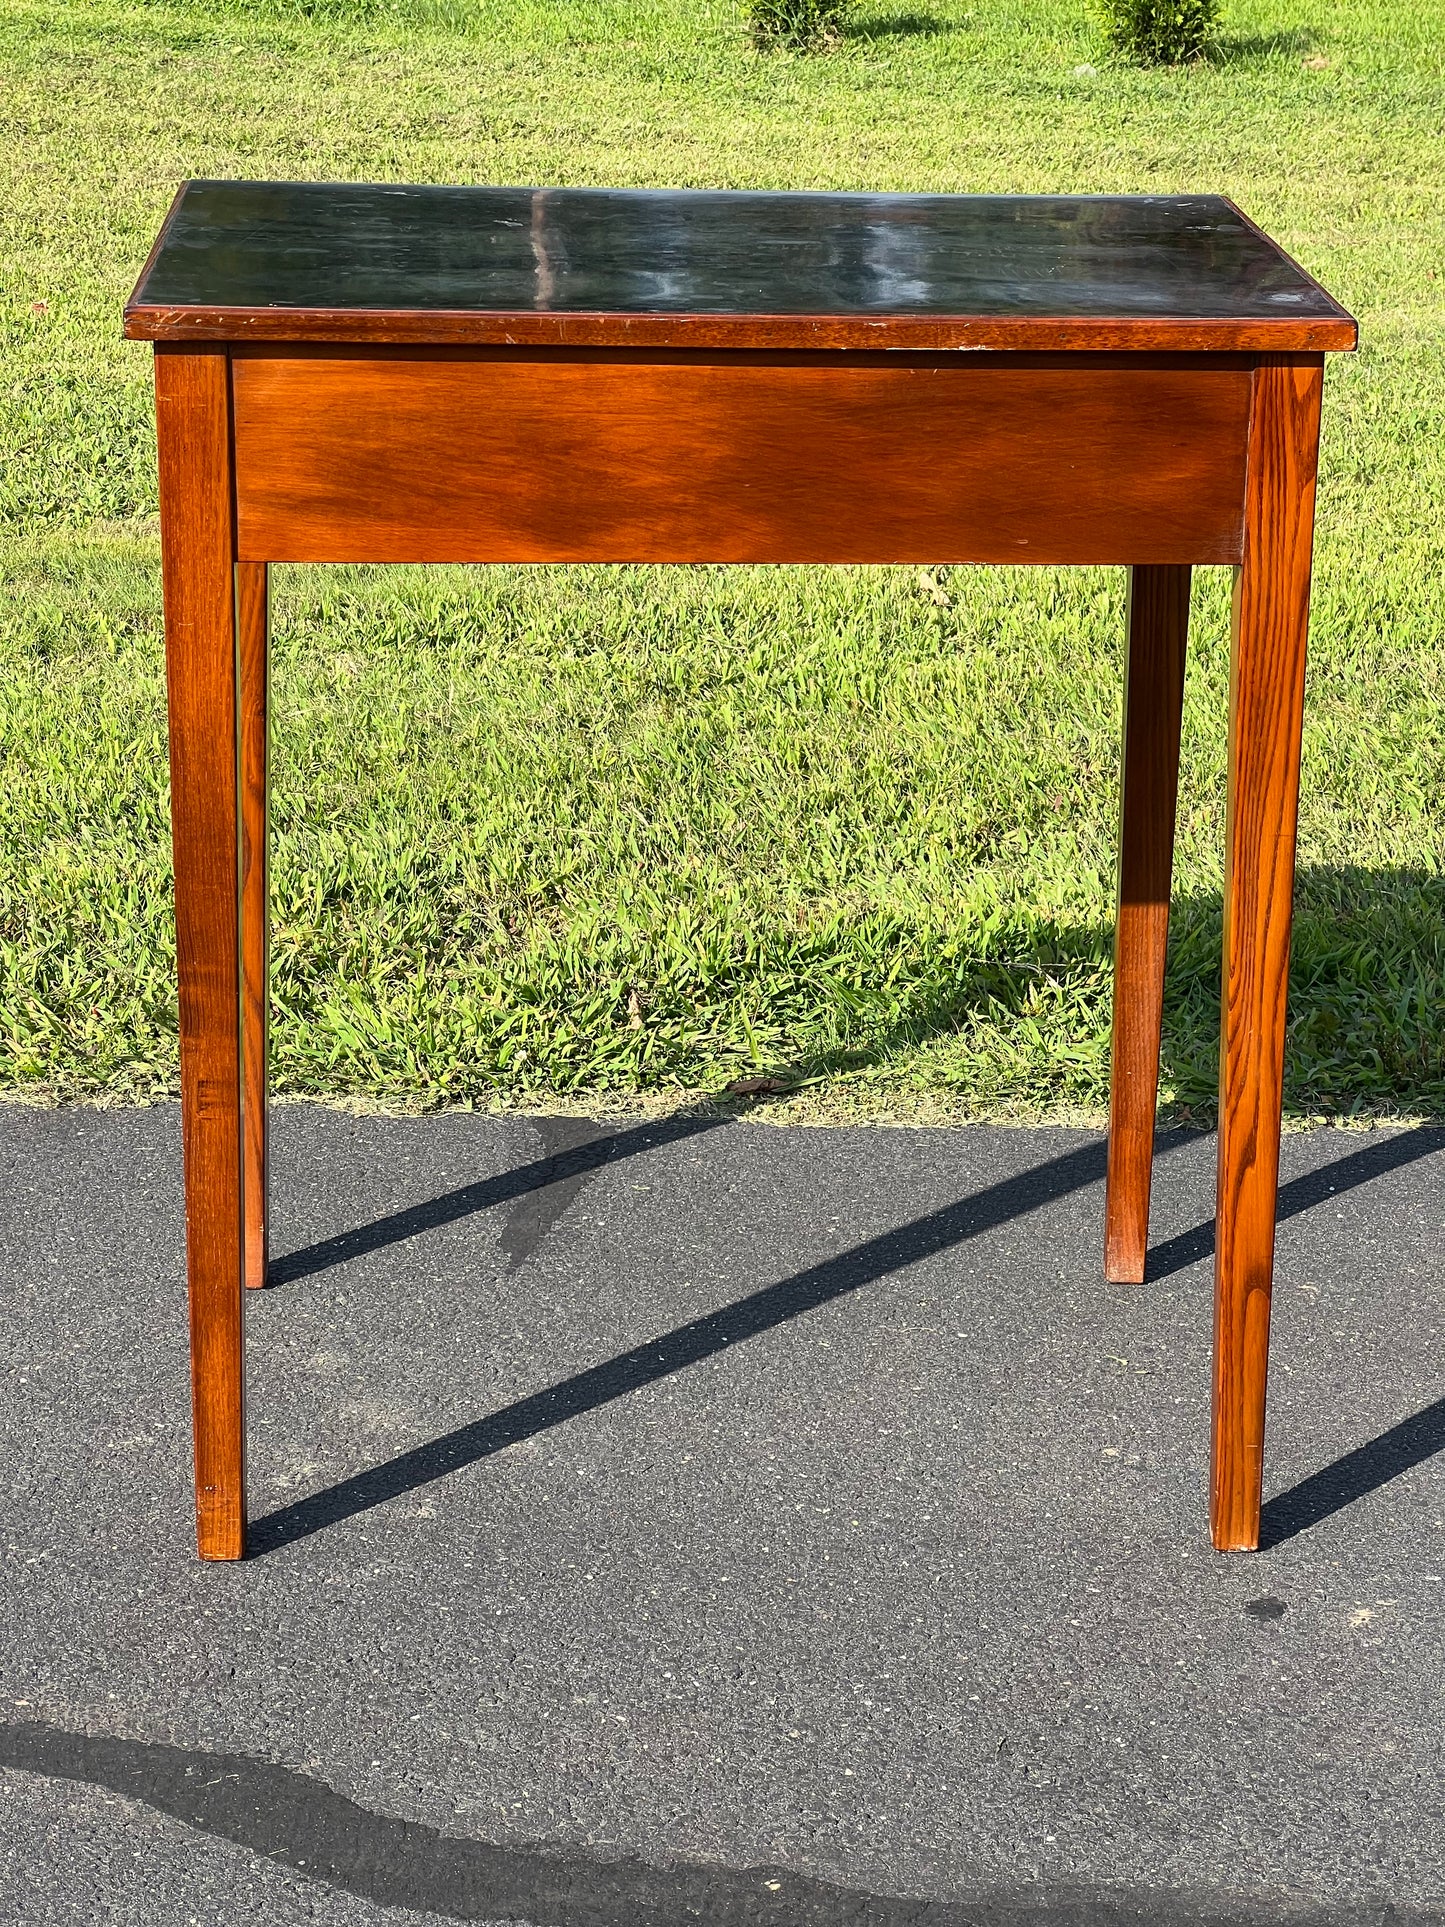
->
125;303;1358;355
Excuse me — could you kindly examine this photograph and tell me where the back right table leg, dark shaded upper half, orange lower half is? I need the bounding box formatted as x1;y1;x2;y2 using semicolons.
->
1104;565;1191;1285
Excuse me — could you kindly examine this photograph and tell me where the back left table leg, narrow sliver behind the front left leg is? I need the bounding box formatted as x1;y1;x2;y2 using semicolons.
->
235;563;270;1291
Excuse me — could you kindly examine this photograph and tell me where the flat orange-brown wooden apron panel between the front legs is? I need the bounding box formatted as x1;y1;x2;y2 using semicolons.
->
231;349;1252;563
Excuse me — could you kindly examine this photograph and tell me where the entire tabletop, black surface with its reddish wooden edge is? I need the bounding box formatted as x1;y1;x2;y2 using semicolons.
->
125;181;1356;355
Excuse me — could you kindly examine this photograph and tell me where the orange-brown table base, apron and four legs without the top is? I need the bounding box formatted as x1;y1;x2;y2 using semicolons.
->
147;318;1348;1559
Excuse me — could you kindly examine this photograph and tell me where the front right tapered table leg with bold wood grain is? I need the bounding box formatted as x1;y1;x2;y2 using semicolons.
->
1210;356;1324;1551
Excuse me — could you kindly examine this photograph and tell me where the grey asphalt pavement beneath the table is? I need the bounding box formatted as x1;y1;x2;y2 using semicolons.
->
0;1106;1445;1927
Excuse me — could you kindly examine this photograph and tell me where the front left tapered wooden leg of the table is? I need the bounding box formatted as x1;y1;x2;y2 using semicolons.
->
156;345;245;1559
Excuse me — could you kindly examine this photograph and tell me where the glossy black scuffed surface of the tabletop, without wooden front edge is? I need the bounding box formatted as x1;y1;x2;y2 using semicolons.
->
135;181;1341;320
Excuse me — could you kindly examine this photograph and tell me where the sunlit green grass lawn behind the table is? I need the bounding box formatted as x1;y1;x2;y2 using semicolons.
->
0;0;1445;1120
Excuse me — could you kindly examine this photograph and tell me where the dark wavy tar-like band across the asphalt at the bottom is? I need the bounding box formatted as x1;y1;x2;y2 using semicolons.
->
0;1721;1445;1927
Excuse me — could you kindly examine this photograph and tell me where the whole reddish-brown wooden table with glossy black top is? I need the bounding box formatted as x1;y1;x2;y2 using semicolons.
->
125;181;1356;1559
